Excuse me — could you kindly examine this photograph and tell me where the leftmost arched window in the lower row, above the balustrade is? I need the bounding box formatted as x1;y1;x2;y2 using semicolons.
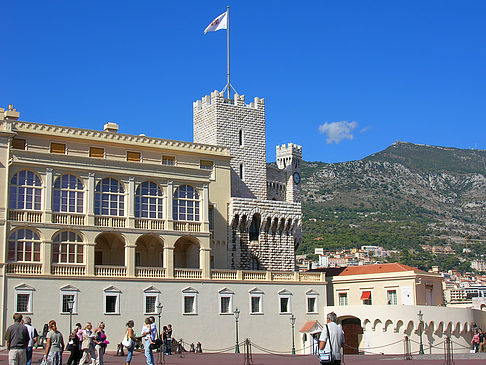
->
8;228;41;262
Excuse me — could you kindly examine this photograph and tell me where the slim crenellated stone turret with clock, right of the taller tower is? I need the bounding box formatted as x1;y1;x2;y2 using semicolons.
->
277;143;302;202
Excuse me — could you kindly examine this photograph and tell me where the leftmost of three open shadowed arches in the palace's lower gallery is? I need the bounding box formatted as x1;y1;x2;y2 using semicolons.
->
95;232;125;266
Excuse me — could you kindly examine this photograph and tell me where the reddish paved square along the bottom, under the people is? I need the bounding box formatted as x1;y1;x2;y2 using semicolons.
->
0;350;486;365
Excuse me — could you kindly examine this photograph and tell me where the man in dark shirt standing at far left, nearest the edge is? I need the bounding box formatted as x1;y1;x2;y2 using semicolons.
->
5;313;29;365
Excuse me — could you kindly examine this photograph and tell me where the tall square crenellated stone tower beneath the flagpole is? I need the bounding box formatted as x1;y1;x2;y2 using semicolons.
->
193;91;267;199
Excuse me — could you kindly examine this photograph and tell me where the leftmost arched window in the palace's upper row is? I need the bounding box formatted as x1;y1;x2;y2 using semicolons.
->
8;170;42;210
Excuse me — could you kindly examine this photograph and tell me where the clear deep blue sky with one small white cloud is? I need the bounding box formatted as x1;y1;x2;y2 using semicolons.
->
0;0;486;162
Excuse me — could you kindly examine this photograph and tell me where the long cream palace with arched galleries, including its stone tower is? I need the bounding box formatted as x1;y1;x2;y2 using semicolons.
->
0;92;318;351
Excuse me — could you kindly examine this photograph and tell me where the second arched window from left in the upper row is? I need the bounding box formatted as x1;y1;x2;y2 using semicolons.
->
52;174;84;213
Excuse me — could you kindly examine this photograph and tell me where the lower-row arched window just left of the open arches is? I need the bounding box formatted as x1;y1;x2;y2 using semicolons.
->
52;231;83;264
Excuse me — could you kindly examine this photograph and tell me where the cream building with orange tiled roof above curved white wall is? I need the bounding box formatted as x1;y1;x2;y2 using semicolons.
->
307;263;486;354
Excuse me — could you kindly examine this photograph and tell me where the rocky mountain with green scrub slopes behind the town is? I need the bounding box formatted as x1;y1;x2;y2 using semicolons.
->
298;142;486;254
